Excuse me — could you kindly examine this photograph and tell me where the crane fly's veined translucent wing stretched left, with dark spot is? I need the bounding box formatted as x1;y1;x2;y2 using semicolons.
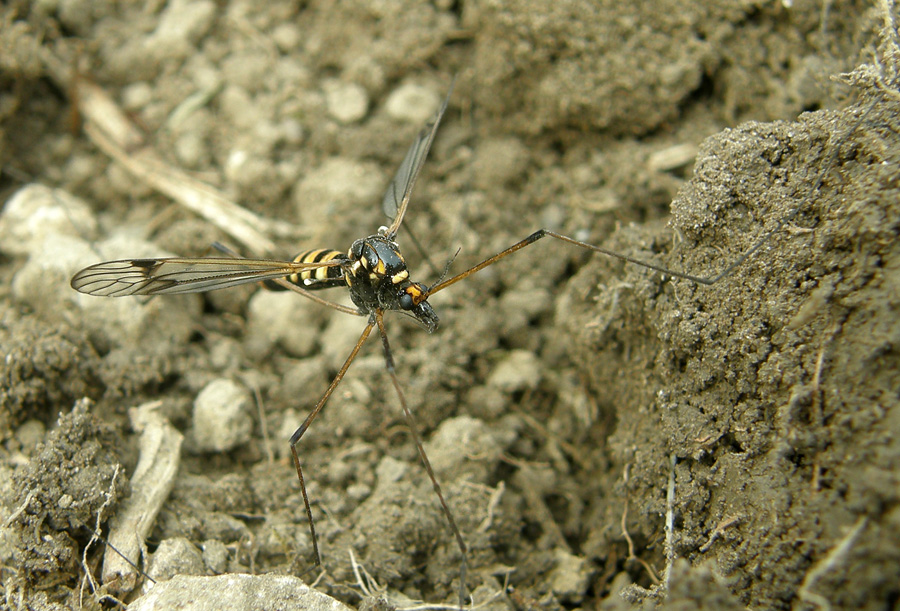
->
70;257;341;297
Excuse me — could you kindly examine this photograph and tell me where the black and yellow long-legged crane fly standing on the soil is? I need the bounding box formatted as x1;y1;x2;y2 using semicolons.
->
71;80;867;605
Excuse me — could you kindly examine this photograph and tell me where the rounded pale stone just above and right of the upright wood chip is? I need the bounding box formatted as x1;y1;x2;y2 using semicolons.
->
193;378;253;452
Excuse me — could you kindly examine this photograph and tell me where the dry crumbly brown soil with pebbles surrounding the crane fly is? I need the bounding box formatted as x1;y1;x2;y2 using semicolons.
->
0;0;900;611
